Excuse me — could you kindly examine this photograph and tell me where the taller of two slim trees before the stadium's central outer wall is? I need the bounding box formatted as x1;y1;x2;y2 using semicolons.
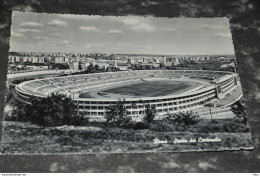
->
105;99;128;127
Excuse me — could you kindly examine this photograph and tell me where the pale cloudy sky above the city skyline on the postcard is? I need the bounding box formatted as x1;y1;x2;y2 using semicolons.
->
10;11;234;55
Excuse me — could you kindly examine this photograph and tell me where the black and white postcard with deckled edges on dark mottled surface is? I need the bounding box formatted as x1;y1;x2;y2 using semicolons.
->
0;11;253;155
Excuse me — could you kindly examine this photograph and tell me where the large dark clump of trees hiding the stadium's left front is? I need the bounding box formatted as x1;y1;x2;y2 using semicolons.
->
10;93;88;126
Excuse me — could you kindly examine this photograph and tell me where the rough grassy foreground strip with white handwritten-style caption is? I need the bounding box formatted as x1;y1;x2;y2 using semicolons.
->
1;121;252;154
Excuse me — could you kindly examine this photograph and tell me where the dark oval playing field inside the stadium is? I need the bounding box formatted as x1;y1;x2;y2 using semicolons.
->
80;80;193;98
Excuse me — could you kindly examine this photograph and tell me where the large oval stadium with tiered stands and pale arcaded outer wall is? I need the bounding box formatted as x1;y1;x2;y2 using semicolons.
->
13;70;238;118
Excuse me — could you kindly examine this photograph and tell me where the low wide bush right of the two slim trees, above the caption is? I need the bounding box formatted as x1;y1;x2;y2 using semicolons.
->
166;111;199;126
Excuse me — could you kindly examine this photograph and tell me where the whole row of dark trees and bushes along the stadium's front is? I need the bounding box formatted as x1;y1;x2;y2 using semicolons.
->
7;93;247;128
